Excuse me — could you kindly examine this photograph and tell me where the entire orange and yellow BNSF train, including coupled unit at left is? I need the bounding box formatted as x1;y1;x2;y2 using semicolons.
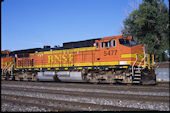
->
1;35;156;84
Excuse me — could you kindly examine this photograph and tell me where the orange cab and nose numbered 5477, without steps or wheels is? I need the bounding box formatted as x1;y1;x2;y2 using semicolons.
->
95;35;145;66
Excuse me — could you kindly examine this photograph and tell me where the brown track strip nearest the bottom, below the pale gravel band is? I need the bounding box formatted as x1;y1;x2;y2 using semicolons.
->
2;94;145;111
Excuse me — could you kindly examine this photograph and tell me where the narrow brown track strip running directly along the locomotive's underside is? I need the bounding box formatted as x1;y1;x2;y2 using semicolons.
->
1;81;169;92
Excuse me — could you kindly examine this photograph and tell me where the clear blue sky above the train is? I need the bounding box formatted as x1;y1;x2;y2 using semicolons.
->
1;0;169;51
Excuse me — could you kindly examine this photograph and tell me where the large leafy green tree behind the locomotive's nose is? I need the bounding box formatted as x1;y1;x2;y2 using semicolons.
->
121;0;169;61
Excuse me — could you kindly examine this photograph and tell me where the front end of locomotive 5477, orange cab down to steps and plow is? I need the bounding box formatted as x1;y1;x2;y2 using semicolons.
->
96;35;156;84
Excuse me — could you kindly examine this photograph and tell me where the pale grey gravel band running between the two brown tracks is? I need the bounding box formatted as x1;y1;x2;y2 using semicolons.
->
1;90;169;111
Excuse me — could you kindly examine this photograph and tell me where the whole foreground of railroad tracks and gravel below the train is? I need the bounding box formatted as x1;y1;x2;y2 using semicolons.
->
1;81;169;111
